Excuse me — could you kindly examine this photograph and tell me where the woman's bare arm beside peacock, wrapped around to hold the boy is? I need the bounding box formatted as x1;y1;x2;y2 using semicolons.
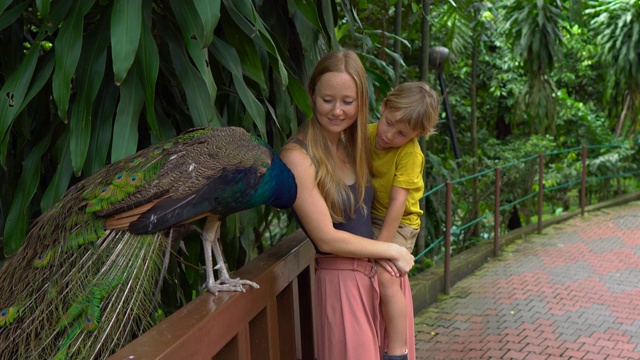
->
280;144;413;273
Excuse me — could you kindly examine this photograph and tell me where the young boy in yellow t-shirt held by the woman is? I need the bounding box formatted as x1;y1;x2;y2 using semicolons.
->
369;82;440;360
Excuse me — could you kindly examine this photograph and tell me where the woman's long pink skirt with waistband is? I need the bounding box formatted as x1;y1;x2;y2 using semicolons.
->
315;255;382;360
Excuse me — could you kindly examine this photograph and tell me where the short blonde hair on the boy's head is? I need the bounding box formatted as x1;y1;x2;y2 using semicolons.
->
384;81;440;136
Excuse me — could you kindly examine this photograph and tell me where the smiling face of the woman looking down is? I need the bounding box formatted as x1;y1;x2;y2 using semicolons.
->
313;72;358;138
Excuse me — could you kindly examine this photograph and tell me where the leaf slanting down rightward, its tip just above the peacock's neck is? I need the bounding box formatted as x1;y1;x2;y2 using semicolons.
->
211;36;267;139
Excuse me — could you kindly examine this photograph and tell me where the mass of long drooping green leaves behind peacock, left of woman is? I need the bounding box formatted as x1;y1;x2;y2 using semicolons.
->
0;0;336;260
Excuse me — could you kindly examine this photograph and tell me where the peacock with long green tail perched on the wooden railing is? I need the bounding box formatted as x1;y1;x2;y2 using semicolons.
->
0;127;297;359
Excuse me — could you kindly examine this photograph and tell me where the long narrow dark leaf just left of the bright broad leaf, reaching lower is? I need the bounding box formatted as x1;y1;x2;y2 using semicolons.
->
70;14;109;176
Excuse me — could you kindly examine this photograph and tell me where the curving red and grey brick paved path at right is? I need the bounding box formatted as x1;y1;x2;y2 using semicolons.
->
415;201;640;360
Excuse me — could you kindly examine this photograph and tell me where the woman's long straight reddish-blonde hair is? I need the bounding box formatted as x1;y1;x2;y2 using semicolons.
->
294;50;370;222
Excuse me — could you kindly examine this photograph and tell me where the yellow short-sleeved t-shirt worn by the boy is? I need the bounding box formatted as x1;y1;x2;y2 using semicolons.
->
369;124;424;229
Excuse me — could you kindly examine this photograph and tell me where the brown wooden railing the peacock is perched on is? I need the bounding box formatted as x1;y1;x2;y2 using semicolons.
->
110;230;315;360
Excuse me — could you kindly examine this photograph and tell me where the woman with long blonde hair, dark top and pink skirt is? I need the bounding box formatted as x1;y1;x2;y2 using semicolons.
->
281;50;413;360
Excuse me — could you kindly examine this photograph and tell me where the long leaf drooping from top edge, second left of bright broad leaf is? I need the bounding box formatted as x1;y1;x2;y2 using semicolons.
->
51;0;95;122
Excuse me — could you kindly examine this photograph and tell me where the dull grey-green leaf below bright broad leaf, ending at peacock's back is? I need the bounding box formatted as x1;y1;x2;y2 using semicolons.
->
111;66;144;162
